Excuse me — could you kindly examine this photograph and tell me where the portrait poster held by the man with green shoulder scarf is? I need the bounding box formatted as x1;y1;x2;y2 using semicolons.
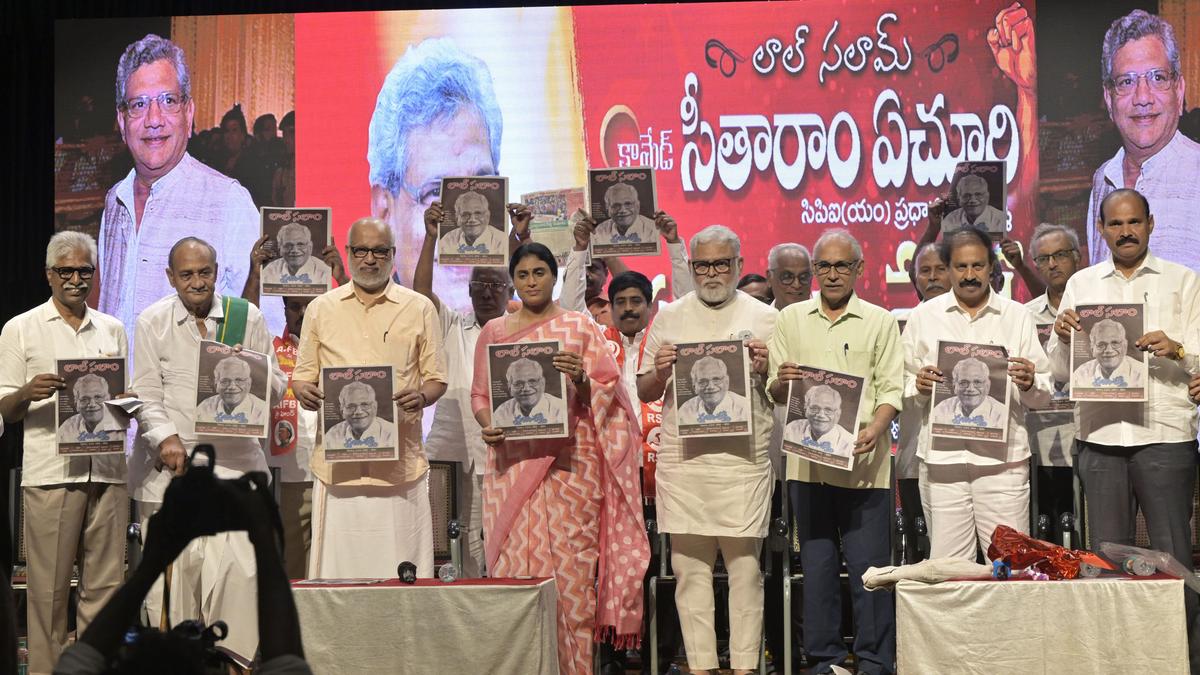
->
194;340;271;438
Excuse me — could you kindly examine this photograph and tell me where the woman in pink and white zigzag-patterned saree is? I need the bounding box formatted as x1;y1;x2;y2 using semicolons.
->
470;244;649;675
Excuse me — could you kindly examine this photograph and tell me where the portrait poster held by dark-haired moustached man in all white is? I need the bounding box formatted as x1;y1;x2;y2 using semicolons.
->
929;340;1009;443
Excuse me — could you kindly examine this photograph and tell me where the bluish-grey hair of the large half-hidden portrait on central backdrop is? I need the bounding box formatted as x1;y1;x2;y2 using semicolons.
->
367;37;504;199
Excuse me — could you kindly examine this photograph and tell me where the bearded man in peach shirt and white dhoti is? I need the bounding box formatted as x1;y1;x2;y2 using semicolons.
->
292;219;446;579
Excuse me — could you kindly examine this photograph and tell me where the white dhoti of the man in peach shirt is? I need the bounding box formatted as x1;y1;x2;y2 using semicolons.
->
308;472;433;579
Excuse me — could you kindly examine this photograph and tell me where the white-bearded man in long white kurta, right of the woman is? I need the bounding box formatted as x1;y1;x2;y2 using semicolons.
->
637;226;779;673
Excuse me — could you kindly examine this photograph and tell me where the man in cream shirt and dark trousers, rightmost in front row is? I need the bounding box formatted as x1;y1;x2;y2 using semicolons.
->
1048;189;1200;670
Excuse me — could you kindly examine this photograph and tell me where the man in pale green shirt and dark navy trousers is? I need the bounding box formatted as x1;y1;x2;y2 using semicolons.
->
768;229;904;673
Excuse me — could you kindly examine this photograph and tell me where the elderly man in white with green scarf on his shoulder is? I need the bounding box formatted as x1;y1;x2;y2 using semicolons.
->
130;239;287;663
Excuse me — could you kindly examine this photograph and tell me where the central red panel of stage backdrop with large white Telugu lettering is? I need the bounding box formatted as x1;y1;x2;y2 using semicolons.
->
295;0;1038;306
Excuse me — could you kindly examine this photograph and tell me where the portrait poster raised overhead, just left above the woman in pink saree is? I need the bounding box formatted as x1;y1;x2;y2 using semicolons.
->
438;175;509;267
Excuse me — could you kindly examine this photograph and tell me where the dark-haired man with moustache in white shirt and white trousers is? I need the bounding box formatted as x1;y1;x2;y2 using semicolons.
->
901;228;1051;560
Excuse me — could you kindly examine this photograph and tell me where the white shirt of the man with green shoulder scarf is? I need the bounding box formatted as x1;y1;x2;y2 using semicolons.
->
130;294;288;502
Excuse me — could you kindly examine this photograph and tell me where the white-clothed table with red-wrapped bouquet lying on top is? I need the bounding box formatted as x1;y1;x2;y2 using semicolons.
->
897;574;1188;675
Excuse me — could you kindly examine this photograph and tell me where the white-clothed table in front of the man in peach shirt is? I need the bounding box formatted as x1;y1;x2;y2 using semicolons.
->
292;571;558;675
